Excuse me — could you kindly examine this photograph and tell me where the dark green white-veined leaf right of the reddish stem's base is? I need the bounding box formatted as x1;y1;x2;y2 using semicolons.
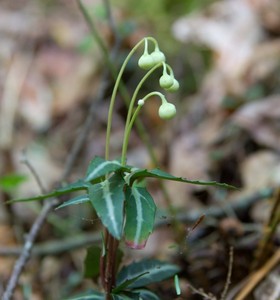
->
117;260;179;288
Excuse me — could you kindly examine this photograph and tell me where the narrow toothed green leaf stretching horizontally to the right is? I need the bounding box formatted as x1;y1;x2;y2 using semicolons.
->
128;169;236;189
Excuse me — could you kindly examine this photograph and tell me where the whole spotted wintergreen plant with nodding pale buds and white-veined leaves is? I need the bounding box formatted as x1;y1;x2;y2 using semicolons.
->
10;37;233;300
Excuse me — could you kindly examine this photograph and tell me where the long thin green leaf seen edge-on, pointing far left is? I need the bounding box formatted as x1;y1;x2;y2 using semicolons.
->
7;180;89;203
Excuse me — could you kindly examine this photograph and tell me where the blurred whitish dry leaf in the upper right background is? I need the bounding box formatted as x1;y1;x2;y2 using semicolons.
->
173;0;262;78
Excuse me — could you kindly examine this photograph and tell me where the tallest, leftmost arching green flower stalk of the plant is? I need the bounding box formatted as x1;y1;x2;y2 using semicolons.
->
105;37;157;159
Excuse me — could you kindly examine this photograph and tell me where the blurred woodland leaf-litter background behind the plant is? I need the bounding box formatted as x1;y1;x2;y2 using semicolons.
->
0;0;280;299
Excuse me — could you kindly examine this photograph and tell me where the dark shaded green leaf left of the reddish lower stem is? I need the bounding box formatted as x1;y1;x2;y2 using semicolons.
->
84;246;101;279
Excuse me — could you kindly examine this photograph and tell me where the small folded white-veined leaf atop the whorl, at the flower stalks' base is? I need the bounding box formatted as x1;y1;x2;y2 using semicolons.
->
85;156;130;181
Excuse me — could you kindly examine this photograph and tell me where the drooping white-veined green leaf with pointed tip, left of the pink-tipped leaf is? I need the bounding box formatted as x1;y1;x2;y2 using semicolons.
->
89;174;125;240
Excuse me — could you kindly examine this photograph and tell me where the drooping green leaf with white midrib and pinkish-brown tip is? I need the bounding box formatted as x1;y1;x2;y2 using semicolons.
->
124;186;156;249
